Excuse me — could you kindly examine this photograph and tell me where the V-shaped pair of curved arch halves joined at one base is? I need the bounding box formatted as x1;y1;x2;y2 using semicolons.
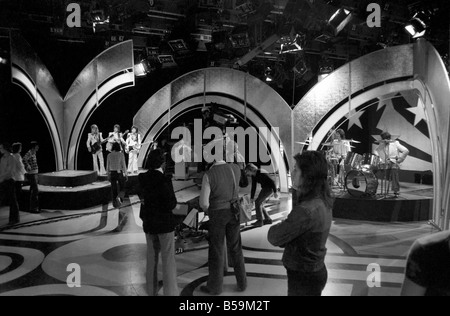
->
11;32;135;170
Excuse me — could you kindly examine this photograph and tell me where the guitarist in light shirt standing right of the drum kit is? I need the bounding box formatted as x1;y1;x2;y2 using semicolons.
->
376;132;409;197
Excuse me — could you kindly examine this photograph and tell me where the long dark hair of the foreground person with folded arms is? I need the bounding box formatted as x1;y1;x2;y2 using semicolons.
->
294;151;334;208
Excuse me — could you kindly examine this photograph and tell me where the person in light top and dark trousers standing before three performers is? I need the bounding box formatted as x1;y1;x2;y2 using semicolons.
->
106;143;128;207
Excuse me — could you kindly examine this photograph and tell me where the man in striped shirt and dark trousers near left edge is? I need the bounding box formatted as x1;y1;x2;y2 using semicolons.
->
23;142;40;214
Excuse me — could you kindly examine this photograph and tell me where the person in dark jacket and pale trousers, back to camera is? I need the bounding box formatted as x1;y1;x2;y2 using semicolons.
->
139;149;179;296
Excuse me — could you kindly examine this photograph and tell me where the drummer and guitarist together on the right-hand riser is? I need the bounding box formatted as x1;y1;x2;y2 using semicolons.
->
323;129;409;197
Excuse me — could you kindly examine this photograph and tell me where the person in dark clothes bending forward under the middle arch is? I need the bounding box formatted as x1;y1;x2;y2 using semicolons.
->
245;164;278;227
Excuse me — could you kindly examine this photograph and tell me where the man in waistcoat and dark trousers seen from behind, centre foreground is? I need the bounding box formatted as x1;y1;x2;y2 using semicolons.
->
200;161;247;295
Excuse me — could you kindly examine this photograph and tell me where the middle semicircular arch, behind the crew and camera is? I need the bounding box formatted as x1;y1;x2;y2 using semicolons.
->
134;68;291;192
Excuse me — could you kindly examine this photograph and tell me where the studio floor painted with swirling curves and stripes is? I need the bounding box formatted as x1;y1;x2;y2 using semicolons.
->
0;196;435;296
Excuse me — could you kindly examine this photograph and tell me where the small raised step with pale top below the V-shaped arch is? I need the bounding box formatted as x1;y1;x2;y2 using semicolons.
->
39;170;97;188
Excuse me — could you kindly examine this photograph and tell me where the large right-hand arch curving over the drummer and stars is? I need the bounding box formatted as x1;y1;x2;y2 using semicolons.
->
292;40;450;229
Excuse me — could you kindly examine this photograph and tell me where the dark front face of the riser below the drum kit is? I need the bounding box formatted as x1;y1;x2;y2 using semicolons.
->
333;198;433;223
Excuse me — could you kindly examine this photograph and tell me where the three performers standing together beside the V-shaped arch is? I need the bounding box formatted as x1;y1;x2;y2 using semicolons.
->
86;124;142;175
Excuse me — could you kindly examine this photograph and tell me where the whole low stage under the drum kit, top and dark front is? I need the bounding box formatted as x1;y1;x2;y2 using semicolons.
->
333;183;434;222
